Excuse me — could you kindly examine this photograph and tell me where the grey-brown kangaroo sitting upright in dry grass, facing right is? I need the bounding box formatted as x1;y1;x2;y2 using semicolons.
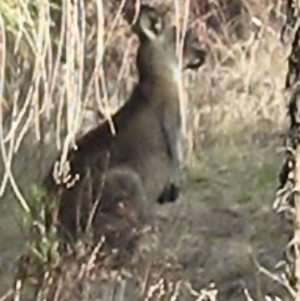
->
44;5;206;244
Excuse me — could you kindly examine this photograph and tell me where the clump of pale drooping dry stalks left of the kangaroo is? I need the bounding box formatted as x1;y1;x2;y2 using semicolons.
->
0;0;113;211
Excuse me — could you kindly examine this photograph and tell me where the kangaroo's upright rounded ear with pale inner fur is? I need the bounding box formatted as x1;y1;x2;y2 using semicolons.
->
133;5;164;40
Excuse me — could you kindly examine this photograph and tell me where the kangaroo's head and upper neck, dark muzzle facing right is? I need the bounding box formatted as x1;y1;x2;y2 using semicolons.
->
133;5;206;80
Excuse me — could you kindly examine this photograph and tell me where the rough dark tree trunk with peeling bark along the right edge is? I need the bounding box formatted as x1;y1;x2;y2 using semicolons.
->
274;1;300;300
